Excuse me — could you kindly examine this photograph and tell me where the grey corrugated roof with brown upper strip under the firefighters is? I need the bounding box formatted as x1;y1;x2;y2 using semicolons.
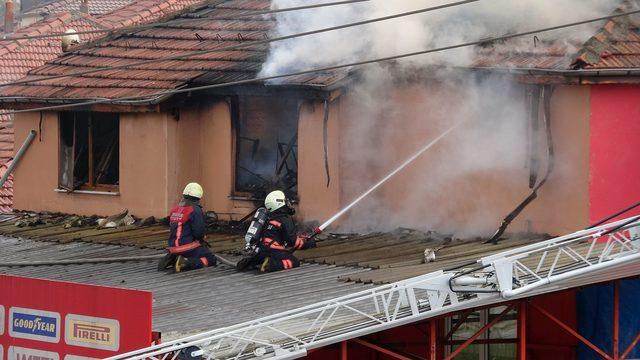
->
0;214;584;344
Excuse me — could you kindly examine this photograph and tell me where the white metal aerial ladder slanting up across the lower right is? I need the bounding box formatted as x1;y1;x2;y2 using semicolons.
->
109;216;640;360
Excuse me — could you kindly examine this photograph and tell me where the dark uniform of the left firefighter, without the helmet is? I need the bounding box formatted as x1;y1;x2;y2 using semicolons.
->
169;198;216;270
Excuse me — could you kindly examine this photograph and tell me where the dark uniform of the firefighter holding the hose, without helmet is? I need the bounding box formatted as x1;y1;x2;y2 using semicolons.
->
256;207;315;272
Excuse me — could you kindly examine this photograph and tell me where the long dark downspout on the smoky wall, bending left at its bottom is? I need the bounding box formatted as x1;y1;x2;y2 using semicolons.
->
485;85;555;245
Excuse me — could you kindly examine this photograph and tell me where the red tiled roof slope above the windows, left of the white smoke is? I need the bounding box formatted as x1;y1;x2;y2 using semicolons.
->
2;0;343;100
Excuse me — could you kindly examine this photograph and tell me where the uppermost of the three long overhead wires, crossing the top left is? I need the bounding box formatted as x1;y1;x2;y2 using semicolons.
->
0;0;372;41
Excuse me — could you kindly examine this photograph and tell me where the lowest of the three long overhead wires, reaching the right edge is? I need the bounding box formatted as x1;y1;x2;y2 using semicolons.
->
0;10;640;114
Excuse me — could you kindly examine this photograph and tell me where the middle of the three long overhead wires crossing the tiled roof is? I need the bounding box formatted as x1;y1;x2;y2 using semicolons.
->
0;0;481;87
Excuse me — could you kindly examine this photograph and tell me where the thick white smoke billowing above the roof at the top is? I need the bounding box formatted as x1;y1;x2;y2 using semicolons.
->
263;0;620;75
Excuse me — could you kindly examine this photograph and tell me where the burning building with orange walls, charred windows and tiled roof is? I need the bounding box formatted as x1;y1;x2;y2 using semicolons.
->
2;1;634;236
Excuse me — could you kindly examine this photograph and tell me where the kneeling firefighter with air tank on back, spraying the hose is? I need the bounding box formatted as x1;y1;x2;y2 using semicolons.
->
237;190;316;272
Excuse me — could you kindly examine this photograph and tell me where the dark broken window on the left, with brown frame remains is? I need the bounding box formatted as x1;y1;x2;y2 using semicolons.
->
59;111;120;191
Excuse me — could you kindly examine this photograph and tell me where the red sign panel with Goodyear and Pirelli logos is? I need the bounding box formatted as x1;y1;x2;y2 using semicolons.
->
0;275;152;360
